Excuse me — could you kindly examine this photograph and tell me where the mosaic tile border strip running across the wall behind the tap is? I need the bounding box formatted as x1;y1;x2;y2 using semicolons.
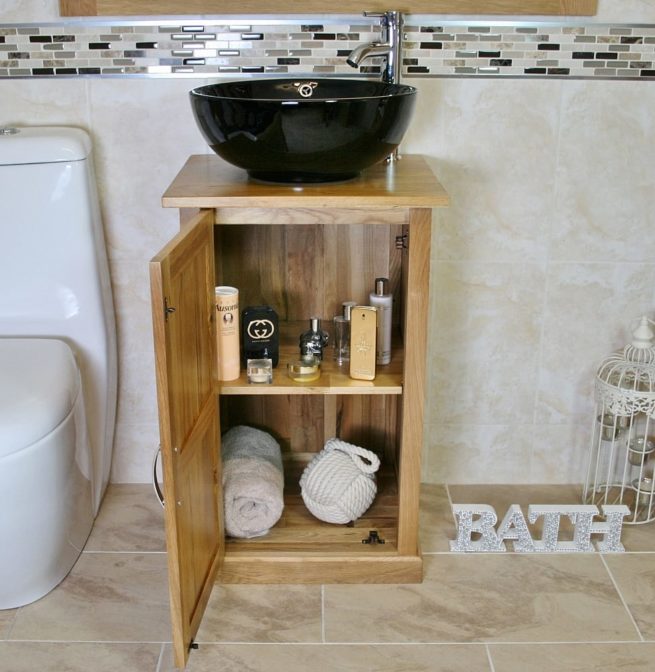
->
0;16;655;81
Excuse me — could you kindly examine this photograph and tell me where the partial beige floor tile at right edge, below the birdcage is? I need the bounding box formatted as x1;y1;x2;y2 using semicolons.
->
604;553;655;644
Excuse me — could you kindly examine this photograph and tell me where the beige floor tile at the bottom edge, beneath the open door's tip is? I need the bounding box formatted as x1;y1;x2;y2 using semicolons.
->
160;644;490;672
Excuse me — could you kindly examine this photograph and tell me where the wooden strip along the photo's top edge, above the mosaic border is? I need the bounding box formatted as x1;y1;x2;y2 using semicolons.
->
59;0;598;16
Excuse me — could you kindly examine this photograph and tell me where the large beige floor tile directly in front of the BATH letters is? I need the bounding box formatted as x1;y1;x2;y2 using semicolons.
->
325;553;638;642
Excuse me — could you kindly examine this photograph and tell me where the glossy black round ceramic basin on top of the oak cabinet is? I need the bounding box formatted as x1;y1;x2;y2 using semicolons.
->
190;79;416;182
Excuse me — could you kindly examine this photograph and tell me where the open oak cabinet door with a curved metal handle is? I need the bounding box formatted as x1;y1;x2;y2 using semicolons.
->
150;210;225;667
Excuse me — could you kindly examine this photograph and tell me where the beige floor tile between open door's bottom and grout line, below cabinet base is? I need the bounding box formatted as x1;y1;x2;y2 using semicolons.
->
196;585;321;642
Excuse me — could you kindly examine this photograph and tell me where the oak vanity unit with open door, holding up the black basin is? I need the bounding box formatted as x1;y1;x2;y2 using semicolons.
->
151;155;448;666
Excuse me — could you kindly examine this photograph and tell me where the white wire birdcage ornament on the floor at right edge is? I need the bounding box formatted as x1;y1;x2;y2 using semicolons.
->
583;317;655;524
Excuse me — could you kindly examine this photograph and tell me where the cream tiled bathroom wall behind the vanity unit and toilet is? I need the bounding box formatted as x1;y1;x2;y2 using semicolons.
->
0;0;655;483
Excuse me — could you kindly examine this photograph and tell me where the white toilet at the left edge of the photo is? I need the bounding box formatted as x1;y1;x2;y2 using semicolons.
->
0;127;116;609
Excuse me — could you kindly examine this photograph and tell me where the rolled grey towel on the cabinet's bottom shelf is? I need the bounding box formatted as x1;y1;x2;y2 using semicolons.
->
221;425;284;539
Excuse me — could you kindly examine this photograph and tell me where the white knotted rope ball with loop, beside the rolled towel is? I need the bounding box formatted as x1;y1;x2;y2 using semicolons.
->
300;439;380;524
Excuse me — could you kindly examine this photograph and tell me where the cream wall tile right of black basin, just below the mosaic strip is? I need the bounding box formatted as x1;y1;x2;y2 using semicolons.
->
406;79;562;262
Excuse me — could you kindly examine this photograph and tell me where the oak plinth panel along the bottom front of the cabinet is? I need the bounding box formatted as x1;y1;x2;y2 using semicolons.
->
216;553;423;584
